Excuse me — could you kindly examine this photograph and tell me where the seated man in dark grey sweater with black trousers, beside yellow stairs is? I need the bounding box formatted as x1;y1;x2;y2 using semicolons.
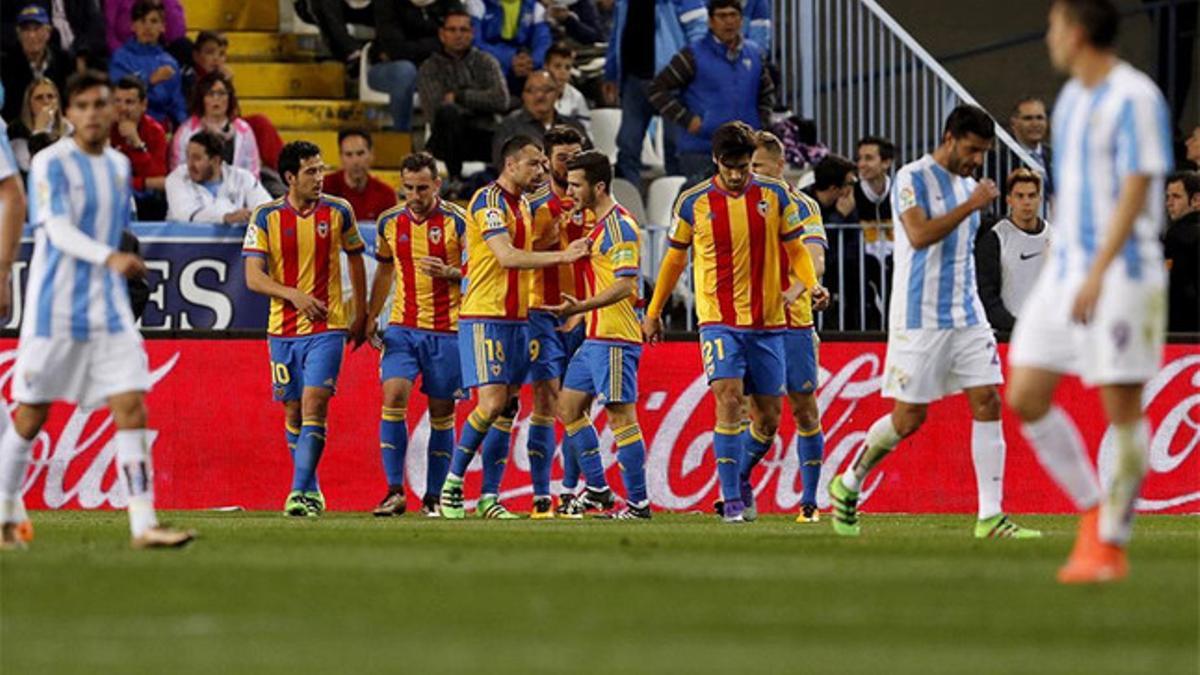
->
416;10;509;189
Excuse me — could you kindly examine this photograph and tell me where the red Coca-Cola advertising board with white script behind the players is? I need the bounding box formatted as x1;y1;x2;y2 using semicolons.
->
9;339;1200;513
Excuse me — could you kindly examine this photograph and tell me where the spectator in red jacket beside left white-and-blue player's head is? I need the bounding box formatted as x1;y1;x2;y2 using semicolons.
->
109;76;167;220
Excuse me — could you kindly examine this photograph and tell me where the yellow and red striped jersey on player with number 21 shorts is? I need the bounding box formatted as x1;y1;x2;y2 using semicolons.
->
668;175;809;329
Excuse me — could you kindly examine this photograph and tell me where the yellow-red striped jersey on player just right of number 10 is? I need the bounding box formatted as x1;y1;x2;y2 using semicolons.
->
376;199;467;333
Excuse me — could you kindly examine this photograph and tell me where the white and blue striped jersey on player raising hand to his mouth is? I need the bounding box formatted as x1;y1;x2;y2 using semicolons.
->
888;155;988;330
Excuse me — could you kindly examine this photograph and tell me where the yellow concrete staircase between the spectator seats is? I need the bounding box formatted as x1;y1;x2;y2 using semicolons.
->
182;0;413;186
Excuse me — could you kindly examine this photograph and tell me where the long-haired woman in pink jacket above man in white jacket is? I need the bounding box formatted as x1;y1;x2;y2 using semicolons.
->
170;71;262;177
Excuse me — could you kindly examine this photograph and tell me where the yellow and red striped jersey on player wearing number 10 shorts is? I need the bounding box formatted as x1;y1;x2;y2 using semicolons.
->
241;195;364;338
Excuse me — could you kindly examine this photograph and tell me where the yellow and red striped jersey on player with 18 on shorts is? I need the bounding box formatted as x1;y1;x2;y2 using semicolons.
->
458;181;533;321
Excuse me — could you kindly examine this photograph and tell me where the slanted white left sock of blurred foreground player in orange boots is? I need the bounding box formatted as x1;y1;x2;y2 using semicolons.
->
1021;406;1100;510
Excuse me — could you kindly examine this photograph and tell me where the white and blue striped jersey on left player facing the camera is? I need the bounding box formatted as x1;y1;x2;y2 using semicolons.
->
22;137;134;340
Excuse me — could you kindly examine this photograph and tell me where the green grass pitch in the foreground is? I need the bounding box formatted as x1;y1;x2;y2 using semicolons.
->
0;512;1200;675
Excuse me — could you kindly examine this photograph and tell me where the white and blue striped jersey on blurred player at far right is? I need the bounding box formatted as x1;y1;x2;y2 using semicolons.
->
1049;61;1172;281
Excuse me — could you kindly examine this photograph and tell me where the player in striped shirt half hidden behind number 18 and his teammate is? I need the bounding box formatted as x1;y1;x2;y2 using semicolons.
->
528;126;588;519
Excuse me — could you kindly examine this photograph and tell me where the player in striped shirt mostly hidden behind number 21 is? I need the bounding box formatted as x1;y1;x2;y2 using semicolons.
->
742;131;829;522
